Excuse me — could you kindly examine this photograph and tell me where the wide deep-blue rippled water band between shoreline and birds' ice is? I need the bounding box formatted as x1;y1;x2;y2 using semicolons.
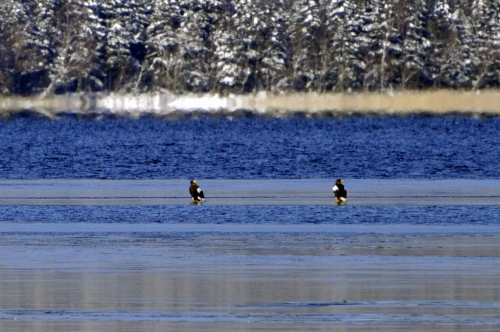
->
0;115;500;179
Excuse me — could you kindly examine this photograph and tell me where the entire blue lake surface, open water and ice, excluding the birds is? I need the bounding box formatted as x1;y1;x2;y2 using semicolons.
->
0;112;500;331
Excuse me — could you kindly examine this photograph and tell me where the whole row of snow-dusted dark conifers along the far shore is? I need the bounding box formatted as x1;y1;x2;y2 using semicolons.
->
0;0;500;94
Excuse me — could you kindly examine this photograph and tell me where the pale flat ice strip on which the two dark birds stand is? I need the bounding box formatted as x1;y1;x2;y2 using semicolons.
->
0;179;500;206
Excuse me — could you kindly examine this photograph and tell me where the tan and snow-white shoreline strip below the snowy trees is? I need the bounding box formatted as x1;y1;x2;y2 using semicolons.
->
0;90;500;117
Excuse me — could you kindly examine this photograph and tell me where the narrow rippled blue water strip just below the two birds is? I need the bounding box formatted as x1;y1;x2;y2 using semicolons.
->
0;205;500;226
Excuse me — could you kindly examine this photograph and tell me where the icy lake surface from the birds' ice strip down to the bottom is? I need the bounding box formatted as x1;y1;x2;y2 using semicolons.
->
0;179;500;332
